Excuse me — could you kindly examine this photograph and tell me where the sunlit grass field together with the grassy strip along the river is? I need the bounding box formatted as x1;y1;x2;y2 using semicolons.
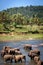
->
0;25;43;41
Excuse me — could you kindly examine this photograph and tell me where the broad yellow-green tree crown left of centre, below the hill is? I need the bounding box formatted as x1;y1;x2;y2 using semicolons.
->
11;13;26;25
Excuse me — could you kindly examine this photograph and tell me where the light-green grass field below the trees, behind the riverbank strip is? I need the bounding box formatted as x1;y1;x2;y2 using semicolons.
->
14;25;43;33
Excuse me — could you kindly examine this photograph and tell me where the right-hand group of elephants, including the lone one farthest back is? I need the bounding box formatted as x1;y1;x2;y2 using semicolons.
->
24;44;43;65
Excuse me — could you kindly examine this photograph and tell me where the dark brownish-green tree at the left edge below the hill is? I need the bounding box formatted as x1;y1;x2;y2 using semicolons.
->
0;12;10;30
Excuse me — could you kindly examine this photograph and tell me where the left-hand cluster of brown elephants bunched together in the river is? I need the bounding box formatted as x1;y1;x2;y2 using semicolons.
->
1;46;26;63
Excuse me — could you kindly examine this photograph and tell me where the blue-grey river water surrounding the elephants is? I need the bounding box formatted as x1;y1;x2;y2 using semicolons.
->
0;40;43;65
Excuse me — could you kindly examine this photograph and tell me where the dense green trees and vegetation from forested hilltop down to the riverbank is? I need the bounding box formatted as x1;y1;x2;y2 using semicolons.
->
0;6;43;33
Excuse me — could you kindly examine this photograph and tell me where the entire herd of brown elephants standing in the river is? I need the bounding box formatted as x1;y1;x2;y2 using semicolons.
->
1;44;43;65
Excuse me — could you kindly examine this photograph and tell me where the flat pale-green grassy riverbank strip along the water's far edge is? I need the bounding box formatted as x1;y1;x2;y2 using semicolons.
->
0;34;43;41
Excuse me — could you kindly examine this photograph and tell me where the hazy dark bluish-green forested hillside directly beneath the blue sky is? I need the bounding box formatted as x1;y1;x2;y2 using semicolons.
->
0;5;43;17
